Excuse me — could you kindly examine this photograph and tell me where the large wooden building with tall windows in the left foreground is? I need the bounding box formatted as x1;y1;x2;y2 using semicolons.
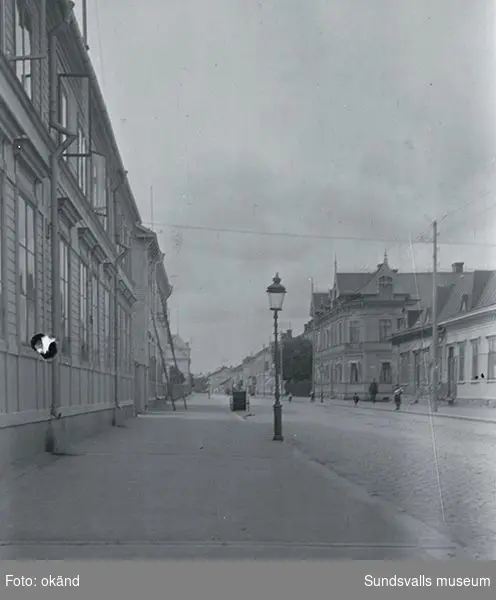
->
0;0;173;460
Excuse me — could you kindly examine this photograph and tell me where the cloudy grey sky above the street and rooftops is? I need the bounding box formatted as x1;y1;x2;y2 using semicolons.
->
76;0;496;372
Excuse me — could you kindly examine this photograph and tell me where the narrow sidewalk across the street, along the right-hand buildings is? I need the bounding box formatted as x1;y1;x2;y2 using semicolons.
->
322;400;496;423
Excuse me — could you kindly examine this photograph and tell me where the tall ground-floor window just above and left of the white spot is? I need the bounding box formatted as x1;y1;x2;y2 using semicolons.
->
17;196;36;344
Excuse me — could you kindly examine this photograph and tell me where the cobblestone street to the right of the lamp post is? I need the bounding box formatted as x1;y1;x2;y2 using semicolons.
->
243;399;496;559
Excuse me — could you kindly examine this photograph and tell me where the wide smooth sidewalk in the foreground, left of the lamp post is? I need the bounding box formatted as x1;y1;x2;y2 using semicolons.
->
0;396;463;560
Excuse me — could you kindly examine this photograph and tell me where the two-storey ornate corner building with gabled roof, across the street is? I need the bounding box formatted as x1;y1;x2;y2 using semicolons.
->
311;256;463;399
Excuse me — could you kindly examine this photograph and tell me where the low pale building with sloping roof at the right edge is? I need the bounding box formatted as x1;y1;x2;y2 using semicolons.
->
392;271;496;405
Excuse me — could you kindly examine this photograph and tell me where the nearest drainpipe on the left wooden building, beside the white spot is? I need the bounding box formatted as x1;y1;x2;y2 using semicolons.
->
46;8;77;436
